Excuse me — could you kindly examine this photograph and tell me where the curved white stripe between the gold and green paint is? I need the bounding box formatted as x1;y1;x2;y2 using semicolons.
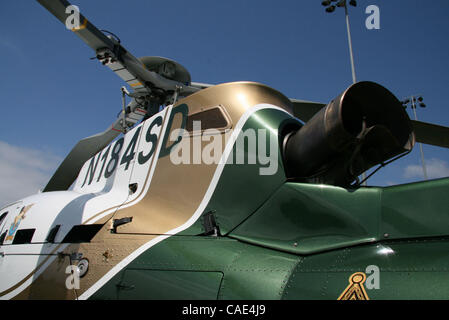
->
79;104;288;300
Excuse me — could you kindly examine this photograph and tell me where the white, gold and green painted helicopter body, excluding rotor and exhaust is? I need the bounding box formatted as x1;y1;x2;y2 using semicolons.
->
0;82;449;299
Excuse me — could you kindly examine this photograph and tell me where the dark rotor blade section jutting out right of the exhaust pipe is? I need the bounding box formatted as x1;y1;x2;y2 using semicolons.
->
412;120;449;148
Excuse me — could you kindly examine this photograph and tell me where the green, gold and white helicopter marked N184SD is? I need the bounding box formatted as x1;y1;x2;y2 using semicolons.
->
0;0;449;300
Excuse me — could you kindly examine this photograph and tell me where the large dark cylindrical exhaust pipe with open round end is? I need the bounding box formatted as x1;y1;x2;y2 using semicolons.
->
283;82;415;187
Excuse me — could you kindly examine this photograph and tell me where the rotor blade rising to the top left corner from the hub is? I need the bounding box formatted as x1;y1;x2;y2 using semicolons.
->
37;0;198;94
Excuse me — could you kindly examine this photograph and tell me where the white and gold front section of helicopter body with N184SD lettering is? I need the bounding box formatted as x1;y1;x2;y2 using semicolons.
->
0;82;291;299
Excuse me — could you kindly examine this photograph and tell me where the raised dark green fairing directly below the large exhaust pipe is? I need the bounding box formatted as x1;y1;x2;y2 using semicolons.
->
231;178;449;255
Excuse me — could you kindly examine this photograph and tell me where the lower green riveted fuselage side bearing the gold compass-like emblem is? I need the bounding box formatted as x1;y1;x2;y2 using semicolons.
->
91;236;449;300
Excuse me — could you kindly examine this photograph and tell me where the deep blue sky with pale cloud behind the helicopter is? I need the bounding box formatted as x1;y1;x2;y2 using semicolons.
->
0;0;449;205
